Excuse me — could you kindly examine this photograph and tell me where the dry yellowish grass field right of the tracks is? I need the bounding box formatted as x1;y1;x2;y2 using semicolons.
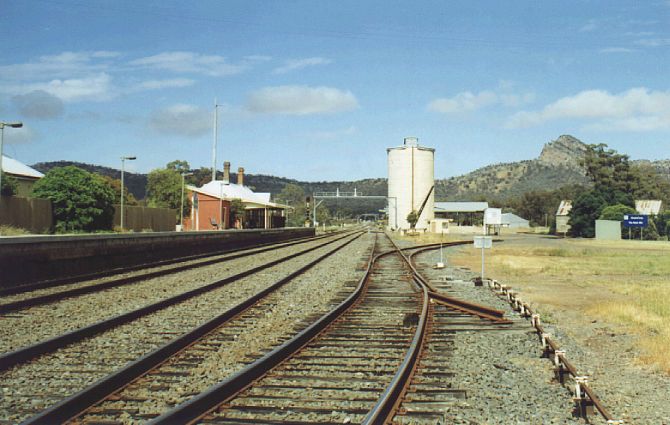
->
400;230;670;373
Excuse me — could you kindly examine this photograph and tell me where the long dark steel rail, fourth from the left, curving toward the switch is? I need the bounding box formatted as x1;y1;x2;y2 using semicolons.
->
148;232;388;425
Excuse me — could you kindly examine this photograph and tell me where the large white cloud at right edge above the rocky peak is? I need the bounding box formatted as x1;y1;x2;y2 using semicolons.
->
506;87;670;131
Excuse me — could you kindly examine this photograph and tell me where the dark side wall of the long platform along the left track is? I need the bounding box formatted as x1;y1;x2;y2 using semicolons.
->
0;228;314;288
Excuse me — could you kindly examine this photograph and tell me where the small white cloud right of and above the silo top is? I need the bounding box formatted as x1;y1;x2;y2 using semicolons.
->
428;88;535;114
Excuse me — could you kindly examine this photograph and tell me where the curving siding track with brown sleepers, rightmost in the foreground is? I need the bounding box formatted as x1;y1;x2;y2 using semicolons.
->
139;235;506;424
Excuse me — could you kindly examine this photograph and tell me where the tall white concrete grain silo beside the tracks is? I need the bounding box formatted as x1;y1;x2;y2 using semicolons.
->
386;137;435;229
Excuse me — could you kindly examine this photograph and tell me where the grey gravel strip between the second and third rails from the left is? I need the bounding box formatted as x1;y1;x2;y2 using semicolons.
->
0;233;368;423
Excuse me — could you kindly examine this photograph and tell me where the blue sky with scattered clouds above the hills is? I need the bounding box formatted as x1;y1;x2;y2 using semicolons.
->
0;0;670;181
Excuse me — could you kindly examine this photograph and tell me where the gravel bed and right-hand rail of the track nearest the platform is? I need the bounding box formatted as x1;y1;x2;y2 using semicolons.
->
0;230;360;356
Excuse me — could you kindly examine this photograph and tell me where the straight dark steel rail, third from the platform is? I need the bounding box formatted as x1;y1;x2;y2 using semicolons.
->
22;233;363;425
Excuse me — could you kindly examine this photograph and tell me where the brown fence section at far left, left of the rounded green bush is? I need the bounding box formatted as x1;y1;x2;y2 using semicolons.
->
0;196;53;233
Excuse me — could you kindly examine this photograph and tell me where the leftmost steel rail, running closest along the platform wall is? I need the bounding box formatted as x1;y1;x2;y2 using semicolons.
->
0;229;356;314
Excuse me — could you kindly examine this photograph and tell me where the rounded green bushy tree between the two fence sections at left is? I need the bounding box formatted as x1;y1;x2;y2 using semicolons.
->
32;166;114;232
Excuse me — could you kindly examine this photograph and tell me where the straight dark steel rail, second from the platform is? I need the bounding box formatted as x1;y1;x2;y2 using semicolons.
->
0;230;356;372
